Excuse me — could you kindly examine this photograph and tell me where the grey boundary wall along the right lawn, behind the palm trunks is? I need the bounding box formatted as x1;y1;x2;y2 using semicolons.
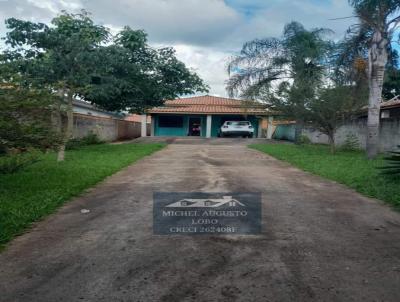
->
303;118;400;151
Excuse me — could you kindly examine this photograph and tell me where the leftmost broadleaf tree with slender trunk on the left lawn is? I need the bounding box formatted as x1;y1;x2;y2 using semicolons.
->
6;11;109;161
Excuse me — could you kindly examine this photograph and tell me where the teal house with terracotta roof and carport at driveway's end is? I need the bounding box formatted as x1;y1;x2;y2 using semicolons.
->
142;95;272;138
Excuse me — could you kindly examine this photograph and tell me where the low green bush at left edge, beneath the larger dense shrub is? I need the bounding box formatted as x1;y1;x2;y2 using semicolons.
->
0;150;40;174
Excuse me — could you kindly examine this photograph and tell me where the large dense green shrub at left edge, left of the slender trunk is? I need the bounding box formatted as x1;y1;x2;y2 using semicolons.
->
0;85;60;153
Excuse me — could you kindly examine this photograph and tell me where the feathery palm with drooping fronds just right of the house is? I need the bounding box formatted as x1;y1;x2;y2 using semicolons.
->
227;22;330;142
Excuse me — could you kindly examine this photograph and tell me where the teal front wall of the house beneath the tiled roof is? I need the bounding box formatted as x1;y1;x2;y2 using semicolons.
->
154;115;258;137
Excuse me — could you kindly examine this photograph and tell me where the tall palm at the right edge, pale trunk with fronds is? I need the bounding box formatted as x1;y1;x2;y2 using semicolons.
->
348;0;400;159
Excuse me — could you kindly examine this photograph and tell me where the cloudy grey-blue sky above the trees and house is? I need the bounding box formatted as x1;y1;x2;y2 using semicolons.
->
0;0;372;96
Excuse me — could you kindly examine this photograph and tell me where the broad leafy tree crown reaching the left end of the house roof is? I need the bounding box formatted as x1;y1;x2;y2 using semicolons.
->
81;27;208;113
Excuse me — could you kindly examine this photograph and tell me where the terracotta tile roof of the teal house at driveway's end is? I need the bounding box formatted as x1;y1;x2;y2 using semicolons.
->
148;95;269;115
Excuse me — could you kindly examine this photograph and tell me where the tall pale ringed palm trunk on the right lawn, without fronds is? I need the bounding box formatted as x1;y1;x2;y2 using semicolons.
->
367;30;388;159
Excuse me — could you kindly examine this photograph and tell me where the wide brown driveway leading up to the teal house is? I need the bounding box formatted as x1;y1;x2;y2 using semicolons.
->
0;140;400;302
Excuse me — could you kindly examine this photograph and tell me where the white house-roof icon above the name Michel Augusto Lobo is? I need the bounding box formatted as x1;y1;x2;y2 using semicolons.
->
166;196;245;208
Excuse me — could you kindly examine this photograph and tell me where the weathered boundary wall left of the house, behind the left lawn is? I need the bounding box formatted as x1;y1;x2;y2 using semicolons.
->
73;113;150;142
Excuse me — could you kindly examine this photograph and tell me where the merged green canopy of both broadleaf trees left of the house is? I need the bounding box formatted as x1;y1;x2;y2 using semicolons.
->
2;11;207;112
